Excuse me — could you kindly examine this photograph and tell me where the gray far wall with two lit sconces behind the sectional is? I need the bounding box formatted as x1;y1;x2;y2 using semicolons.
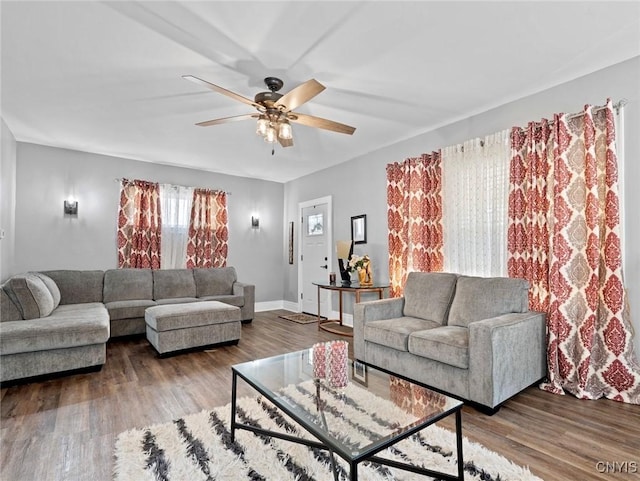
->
10;142;284;302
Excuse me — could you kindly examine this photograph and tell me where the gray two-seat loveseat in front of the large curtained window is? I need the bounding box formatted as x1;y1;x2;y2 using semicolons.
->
353;272;546;413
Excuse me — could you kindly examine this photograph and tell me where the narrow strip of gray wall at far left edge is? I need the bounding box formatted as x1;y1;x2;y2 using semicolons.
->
0;119;16;282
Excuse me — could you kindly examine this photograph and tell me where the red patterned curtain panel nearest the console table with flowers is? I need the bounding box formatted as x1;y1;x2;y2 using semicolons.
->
387;151;443;297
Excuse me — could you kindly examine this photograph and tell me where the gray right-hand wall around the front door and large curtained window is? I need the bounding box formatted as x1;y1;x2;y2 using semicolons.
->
284;57;640;353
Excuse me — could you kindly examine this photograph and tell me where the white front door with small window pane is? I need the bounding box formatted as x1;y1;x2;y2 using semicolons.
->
300;203;331;316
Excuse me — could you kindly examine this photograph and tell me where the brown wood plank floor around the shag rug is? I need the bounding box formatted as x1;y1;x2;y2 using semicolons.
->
0;311;640;481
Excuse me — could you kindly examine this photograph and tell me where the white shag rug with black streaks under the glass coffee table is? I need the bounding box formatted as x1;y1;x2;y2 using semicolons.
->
114;383;541;481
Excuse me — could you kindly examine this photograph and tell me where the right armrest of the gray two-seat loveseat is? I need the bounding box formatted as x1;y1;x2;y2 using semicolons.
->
469;311;547;408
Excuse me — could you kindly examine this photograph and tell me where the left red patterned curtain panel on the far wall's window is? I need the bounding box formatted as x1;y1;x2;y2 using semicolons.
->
118;179;162;269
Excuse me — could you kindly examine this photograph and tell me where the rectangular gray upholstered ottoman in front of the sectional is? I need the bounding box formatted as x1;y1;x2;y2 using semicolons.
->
144;301;241;355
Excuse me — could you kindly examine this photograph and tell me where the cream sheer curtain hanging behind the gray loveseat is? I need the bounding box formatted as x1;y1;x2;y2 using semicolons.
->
442;129;510;276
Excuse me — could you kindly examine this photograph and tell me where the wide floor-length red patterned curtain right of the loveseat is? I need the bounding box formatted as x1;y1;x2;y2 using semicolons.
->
508;100;640;404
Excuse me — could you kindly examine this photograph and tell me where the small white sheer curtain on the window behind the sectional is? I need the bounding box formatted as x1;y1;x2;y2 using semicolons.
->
160;184;193;269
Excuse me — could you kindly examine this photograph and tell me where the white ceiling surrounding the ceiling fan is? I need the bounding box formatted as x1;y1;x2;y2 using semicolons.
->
0;0;640;182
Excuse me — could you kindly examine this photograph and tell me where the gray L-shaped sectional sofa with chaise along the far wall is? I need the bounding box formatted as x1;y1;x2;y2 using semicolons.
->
0;267;255;383
